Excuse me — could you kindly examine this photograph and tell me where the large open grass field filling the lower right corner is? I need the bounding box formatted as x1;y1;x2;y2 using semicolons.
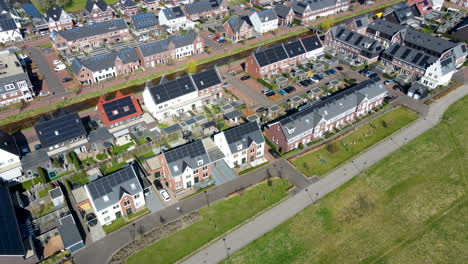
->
225;97;468;264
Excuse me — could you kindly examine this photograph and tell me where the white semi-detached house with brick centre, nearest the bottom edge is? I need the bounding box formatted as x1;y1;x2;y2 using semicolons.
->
85;162;146;226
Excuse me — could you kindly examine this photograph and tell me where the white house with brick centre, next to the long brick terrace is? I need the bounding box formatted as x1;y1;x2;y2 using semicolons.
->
213;122;265;168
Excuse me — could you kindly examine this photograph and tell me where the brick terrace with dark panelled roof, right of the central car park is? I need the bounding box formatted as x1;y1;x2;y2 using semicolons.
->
325;26;384;64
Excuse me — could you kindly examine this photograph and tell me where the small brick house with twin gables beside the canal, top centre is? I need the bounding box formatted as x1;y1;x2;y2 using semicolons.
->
223;16;255;42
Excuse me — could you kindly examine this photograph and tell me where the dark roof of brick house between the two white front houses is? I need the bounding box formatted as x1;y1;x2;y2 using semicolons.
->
163;140;211;177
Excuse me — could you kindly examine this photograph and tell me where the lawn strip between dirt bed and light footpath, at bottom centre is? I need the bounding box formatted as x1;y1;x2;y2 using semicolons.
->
127;179;290;264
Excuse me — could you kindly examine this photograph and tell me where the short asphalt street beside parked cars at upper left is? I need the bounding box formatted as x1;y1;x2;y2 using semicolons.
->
26;47;67;96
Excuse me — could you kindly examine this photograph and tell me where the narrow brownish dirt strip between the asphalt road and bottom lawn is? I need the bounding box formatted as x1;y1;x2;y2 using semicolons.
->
109;212;202;264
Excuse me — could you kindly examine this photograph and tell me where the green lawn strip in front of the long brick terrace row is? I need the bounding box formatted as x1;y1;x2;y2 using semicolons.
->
292;107;418;177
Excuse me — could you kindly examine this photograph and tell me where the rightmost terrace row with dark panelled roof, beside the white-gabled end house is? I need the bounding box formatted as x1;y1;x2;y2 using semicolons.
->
381;44;437;78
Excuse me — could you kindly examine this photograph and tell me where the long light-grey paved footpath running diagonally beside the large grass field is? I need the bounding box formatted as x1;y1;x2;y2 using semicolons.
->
183;82;468;264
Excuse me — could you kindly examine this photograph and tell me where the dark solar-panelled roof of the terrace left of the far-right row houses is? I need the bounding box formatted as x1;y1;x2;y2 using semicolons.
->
330;26;383;58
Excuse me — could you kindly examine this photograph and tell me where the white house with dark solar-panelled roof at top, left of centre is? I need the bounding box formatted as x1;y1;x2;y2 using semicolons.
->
158;6;195;33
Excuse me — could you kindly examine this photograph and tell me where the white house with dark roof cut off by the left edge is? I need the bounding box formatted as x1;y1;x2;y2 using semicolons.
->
0;130;23;181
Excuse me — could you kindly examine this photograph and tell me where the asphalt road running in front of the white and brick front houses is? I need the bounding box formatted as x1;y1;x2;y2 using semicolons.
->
74;160;310;264
